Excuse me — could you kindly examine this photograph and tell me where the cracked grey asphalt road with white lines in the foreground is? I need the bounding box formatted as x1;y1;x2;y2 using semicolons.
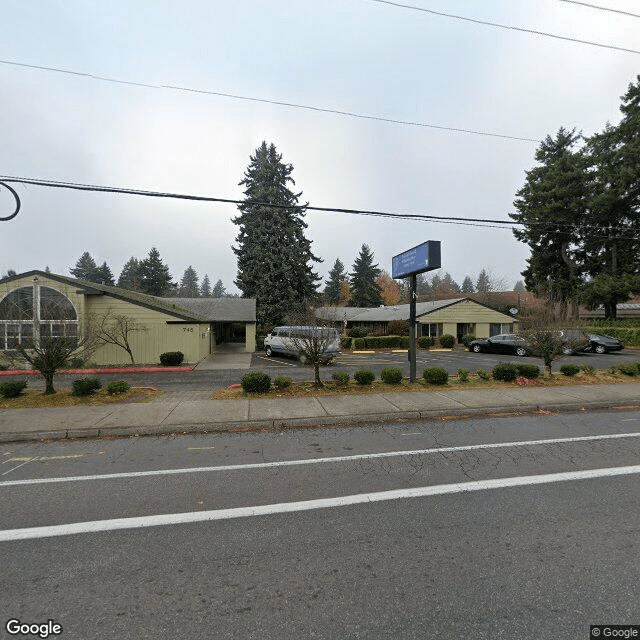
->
0;412;640;640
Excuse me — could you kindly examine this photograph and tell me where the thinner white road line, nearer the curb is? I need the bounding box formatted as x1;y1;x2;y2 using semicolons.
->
0;432;640;488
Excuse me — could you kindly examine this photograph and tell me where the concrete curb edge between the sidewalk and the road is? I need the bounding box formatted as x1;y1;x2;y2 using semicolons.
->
0;400;640;444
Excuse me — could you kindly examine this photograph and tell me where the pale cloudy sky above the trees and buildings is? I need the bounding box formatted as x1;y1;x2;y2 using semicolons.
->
0;0;640;291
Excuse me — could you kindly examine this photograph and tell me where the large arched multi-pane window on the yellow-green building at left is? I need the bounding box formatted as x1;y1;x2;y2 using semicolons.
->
0;283;78;350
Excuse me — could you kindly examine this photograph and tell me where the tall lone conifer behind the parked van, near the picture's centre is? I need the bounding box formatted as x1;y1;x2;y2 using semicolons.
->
233;142;321;324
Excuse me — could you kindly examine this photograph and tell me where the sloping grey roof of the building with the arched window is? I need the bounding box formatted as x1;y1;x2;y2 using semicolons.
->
0;270;256;322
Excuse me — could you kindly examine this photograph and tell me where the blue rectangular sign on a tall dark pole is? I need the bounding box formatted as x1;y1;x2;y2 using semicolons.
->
391;240;440;382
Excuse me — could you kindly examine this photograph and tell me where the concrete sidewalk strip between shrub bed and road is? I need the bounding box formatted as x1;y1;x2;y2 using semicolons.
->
0;384;640;442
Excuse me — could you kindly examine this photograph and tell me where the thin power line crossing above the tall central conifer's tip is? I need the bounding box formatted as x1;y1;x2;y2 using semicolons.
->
0;60;542;142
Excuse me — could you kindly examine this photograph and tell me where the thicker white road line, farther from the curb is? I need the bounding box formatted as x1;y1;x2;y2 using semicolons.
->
0;465;640;542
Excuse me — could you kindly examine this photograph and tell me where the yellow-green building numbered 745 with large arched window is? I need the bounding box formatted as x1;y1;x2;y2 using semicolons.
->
0;271;256;365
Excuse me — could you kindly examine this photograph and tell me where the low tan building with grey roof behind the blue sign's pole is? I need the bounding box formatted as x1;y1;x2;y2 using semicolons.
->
316;298;517;340
